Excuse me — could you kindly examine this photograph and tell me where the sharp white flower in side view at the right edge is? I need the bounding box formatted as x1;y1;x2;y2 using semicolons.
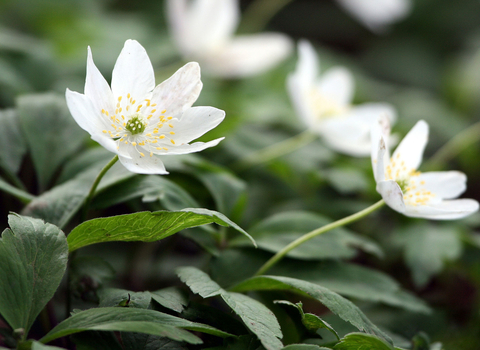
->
372;119;478;220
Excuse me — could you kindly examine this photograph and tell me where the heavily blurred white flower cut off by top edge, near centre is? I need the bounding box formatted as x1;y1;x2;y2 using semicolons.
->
167;0;292;78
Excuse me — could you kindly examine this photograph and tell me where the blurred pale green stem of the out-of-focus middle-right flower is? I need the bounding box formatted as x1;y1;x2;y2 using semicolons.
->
233;130;317;171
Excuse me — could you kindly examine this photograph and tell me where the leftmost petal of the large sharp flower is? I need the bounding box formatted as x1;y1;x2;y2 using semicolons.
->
65;89;105;135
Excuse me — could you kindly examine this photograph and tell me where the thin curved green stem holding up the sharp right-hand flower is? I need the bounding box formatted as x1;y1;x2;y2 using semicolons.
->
255;199;385;276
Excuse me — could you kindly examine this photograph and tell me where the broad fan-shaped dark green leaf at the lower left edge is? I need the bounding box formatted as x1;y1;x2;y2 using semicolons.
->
0;214;68;335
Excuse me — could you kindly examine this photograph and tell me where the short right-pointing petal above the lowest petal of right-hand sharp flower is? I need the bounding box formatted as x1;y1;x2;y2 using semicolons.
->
416;171;467;199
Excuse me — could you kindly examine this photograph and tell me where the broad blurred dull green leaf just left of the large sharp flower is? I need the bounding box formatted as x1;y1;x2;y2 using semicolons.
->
17;93;87;191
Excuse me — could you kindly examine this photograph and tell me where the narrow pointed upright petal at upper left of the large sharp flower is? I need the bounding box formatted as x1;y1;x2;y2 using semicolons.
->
85;47;115;113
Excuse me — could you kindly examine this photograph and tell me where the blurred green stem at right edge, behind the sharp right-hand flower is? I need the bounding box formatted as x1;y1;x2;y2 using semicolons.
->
424;122;480;169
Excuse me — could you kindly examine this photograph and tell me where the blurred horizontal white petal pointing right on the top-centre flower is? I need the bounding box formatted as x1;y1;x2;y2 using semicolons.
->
200;33;292;78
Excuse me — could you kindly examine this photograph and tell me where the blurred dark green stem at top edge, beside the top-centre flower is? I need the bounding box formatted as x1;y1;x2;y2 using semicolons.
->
241;0;292;33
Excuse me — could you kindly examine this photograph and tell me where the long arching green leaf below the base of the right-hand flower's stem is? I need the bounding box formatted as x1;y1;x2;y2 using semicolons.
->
231;276;390;342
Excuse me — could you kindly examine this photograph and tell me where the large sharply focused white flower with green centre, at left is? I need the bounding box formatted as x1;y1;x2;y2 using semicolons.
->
66;40;225;174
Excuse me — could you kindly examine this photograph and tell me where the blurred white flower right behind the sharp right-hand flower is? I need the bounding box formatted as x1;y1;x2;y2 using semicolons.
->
287;41;395;156
